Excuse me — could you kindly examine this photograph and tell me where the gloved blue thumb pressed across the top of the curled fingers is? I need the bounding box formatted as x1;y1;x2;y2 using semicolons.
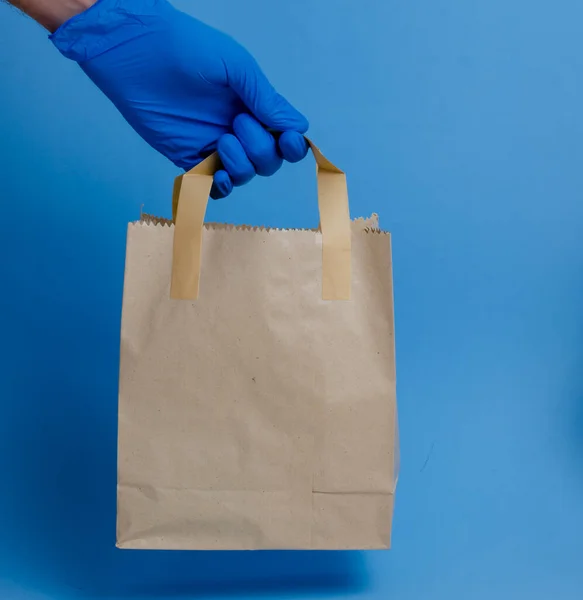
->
225;51;309;133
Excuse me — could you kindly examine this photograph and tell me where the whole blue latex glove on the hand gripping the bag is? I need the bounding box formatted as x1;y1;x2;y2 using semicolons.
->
51;0;308;198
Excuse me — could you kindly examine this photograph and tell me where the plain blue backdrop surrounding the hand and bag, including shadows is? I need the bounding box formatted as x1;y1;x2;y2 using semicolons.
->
0;0;583;600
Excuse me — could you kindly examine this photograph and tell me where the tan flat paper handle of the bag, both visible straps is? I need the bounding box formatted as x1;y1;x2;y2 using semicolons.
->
170;138;351;300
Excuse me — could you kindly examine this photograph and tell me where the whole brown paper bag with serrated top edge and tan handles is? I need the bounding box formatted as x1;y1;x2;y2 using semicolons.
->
117;143;398;549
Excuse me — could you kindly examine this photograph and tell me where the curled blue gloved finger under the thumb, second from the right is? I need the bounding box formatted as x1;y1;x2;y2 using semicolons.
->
233;113;283;177
